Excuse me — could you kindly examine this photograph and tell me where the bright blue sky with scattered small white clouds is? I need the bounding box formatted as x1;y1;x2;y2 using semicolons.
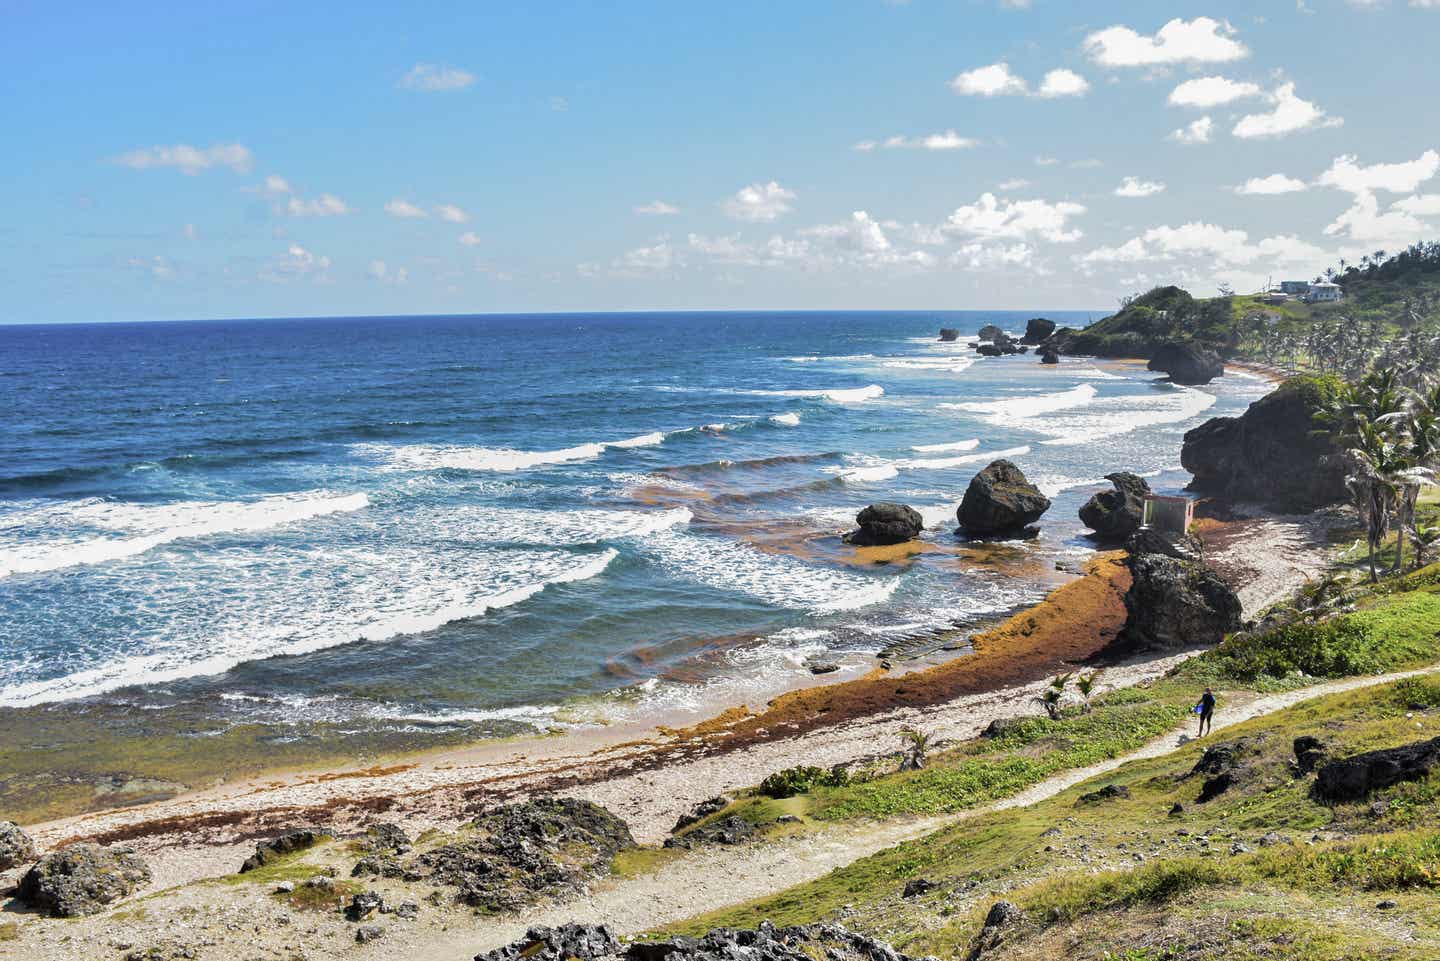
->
0;0;1440;323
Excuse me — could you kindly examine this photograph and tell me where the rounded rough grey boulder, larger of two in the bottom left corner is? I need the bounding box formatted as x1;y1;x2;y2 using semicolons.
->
17;844;150;918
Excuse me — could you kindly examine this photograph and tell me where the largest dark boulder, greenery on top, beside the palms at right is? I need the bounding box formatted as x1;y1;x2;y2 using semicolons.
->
1179;376;1349;513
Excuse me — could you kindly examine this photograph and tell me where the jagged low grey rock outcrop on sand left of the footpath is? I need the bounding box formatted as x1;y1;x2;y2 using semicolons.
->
405;798;635;911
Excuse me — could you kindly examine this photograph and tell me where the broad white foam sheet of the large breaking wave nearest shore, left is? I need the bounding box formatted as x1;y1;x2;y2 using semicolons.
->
0;545;618;707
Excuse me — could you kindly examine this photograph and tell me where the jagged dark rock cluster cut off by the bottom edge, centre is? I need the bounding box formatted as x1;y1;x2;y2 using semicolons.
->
475;921;927;961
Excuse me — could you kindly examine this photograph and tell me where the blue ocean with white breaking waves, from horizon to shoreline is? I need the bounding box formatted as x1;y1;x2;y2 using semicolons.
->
0;311;1266;725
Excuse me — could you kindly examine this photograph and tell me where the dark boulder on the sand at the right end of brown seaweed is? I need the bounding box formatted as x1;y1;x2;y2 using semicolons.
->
1120;553;1241;651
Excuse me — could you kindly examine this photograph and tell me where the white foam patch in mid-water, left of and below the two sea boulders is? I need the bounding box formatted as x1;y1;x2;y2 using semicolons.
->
641;529;900;614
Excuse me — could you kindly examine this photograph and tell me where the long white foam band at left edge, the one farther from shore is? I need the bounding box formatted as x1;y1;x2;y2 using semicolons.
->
0;491;370;578
